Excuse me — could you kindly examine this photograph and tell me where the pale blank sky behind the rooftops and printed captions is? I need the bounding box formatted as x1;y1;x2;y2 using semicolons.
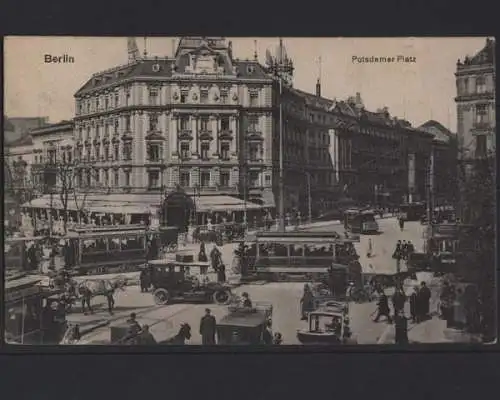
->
4;36;486;132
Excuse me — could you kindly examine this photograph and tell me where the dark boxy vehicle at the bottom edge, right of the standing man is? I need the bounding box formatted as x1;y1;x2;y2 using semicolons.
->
216;302;273;346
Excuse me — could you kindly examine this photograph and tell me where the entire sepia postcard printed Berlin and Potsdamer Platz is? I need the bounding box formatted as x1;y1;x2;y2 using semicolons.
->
3;36;497;347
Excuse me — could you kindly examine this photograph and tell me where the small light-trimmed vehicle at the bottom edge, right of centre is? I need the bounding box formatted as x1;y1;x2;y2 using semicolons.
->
297;301;357;345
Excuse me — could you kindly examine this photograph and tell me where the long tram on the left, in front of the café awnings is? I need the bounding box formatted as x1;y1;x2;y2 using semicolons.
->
63;224;177;275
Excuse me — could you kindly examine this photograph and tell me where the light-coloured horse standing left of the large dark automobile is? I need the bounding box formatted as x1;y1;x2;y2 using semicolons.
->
72;277;127;314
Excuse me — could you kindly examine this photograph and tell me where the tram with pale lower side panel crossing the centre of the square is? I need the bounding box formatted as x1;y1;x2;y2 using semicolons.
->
239;232;358;281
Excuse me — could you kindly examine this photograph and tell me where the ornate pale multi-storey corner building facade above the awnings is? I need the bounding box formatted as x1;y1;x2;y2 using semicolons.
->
74;37;273;223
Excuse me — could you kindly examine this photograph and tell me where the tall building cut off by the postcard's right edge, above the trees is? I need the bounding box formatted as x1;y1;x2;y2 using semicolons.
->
455;39;496;159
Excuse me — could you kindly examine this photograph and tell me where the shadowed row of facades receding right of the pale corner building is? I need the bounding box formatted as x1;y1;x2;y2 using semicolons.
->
283;82;434;214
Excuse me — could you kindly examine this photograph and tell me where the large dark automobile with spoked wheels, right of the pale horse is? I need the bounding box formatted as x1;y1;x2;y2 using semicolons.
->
143;259;232;305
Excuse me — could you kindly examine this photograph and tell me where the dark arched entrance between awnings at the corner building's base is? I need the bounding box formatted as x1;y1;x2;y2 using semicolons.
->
160;188;195;233
